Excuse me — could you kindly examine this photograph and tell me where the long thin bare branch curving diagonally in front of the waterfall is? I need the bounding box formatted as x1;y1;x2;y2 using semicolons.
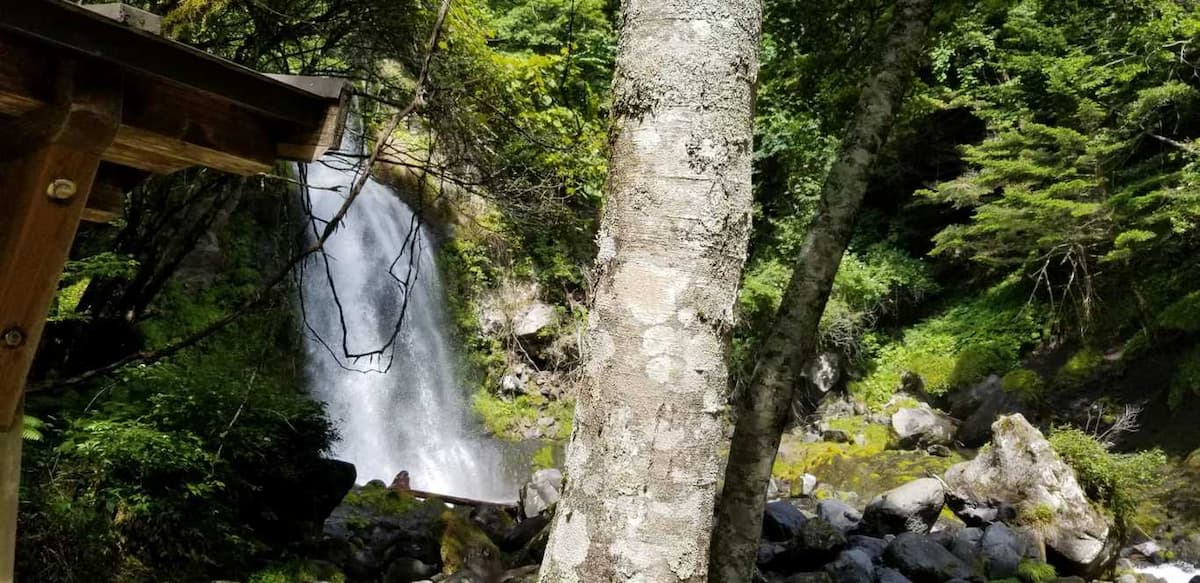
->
26;0;450;392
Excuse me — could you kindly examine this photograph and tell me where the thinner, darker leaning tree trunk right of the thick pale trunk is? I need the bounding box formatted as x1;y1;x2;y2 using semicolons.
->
710;0;934;583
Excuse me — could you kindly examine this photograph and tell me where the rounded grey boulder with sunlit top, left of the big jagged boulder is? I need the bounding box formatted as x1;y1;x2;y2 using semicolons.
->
863;477;946;536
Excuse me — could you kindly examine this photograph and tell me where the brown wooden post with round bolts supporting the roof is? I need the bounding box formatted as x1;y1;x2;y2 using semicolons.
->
0;74;121;583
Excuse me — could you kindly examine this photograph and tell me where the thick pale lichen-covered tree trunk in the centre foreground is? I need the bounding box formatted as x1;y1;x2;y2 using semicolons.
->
540;0;761;583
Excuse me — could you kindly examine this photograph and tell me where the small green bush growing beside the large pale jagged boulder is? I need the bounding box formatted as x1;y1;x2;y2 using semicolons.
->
1049;427;1166;533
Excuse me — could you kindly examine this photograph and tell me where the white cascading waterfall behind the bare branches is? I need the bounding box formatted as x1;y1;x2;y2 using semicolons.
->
301;121;522;500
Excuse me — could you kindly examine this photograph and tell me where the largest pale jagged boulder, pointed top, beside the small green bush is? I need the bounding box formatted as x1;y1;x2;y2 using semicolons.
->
946;414;1112;575
